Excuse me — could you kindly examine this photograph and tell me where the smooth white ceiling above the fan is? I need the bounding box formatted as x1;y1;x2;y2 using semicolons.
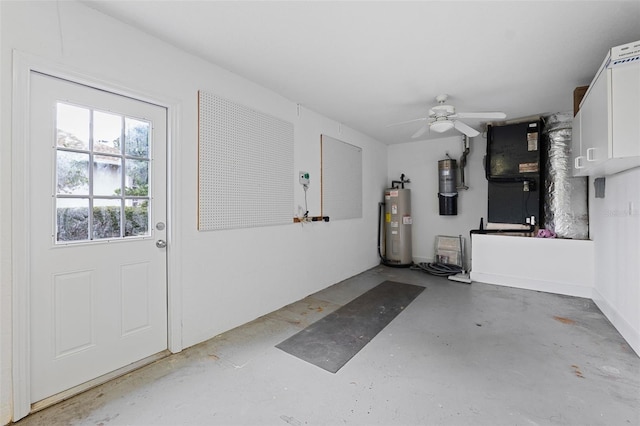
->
85;0;640;144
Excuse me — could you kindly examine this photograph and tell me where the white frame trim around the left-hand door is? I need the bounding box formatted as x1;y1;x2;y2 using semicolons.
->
11;50;183;421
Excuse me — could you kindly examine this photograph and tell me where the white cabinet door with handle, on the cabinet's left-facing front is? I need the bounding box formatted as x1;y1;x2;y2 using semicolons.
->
580;70;610;169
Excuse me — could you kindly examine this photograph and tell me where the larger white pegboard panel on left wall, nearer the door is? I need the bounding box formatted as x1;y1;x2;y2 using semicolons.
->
198;91;294;231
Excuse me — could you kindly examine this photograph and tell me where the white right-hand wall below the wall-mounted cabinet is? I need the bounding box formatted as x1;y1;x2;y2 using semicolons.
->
589;168;640;355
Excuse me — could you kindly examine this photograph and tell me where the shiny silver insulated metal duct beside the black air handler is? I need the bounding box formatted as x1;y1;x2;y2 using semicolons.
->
542;112;589;240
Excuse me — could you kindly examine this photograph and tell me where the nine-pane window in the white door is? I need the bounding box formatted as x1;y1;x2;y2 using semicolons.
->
55;102;151;243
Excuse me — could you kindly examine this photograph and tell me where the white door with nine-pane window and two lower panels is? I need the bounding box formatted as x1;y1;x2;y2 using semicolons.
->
27;72;167;402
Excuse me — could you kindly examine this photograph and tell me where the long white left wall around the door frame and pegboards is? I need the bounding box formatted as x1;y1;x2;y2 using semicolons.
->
0;1;387;424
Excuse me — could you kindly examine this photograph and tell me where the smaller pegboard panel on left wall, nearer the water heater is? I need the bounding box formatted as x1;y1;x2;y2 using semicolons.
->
320;135;362;221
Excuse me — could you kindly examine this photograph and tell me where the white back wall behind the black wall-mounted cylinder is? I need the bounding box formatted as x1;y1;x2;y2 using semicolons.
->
380;136;488;266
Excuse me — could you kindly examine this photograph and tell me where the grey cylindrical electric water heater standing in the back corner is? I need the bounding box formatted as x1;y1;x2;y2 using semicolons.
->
384;188;413;266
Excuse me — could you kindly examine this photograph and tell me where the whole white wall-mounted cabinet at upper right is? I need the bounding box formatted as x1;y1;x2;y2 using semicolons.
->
572;42;640;176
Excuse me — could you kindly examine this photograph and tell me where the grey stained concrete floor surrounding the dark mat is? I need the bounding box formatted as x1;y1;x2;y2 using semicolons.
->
12;266;640;426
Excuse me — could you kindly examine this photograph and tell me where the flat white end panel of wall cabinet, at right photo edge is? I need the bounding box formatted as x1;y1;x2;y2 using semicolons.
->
611;64;640;158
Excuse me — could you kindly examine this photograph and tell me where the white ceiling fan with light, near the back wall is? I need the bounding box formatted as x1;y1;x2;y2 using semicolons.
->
387;95;507;138
